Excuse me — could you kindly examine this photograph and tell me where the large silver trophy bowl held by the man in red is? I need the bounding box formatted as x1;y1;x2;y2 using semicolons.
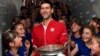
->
38;44;65;56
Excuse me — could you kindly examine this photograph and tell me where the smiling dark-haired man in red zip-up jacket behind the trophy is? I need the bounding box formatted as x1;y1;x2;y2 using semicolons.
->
32;1;67;56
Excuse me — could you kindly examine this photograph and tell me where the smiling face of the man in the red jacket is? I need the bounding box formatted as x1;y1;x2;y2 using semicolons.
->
40;3;53;19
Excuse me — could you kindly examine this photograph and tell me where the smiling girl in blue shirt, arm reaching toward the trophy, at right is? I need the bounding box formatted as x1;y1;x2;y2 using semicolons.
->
71;26;95;56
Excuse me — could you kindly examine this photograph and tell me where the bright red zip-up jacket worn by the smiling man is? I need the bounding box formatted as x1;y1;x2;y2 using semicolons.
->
32;20;68;56
